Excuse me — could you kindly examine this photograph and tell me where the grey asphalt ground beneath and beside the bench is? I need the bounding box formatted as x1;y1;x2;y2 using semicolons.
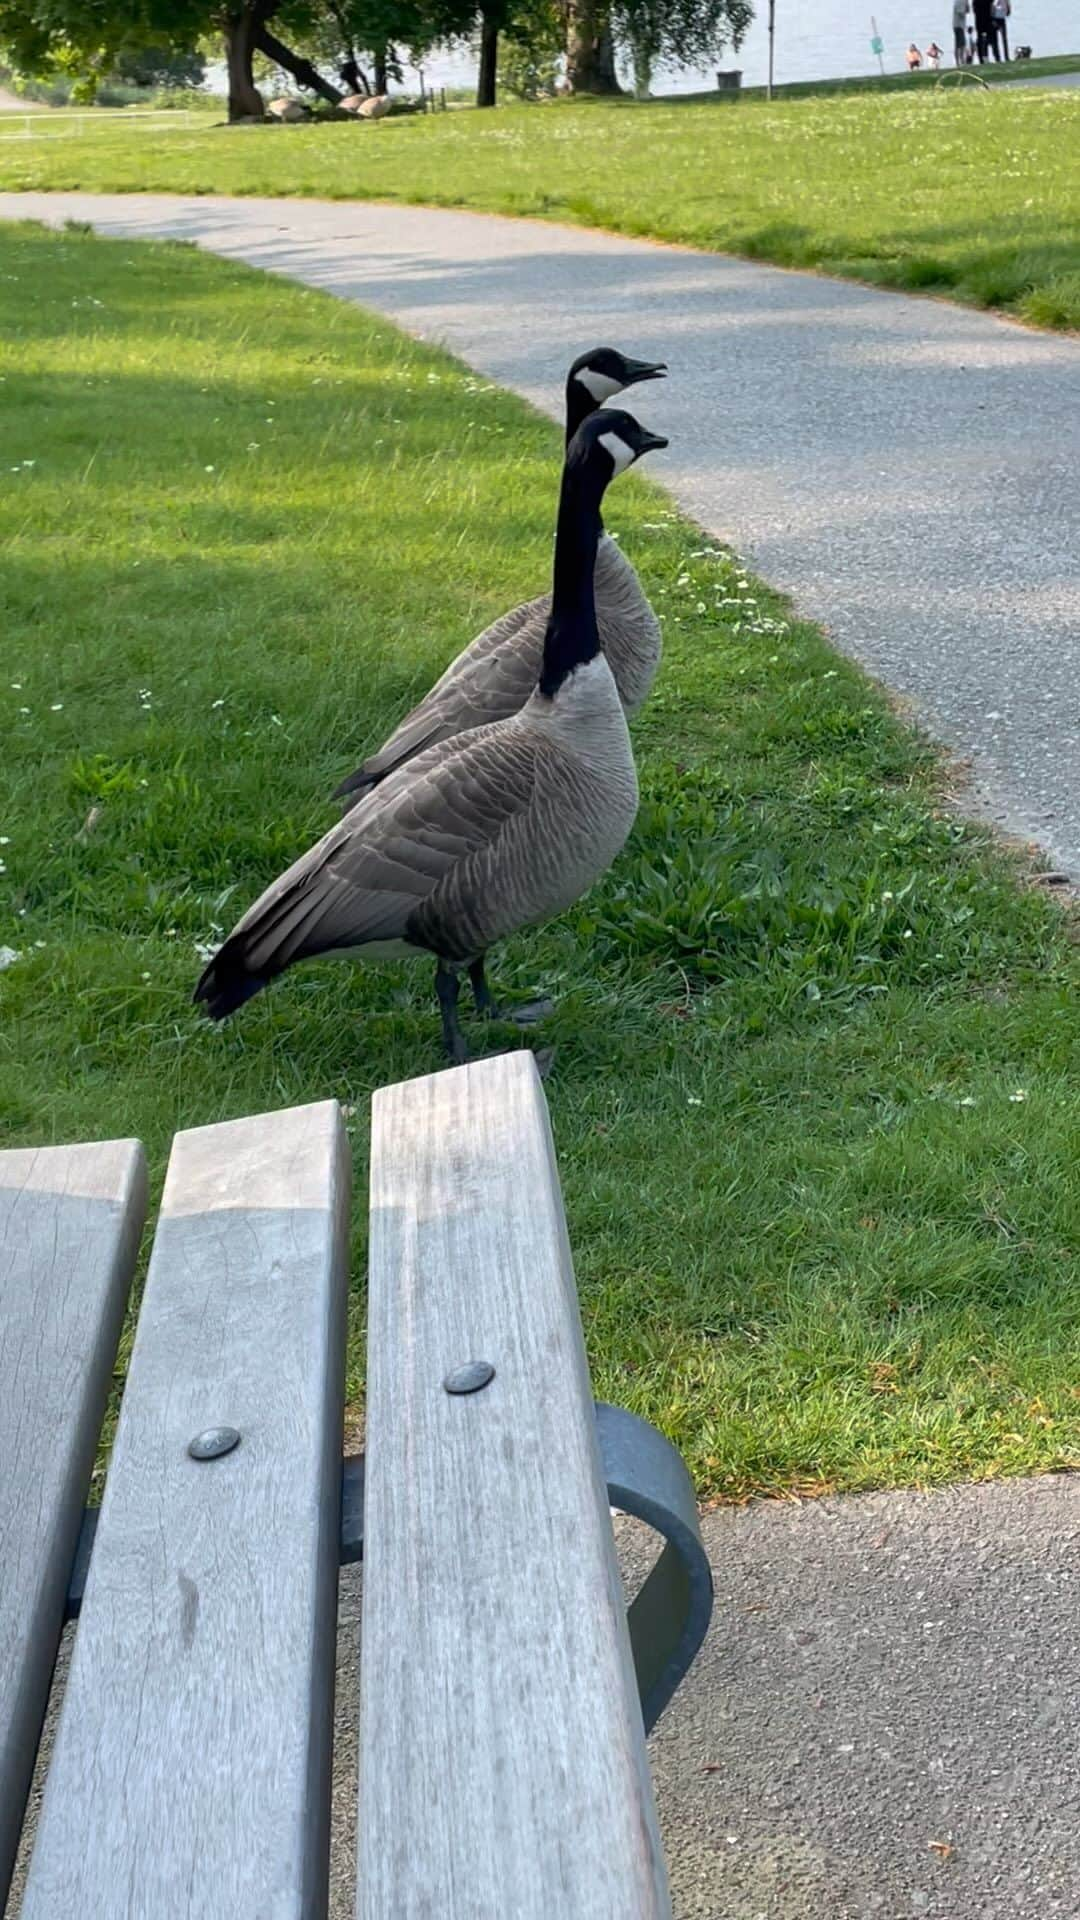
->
10;1476;1080;1920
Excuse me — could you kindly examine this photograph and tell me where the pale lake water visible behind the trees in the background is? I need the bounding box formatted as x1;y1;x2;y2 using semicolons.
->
417;0;1080;92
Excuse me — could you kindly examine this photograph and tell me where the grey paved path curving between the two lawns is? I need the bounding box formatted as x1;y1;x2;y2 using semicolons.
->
0;194;1080;875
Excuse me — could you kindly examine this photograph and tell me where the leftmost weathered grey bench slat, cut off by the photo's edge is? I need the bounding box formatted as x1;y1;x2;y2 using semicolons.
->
0;1140;146;1910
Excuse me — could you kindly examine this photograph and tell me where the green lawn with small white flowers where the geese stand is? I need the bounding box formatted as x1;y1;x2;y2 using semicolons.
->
0;225;1080;1496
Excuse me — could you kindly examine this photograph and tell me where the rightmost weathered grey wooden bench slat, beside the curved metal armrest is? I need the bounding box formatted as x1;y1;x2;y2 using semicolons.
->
356;1052;671;1920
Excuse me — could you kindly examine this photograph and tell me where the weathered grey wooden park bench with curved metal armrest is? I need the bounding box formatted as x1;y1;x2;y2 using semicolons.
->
0;1052;711;1920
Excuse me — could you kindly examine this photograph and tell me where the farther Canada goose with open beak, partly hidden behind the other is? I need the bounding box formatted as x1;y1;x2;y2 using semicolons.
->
332;348;667;806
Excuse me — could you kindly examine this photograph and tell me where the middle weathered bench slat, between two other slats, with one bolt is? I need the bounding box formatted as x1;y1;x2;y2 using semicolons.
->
23;1102;350;1920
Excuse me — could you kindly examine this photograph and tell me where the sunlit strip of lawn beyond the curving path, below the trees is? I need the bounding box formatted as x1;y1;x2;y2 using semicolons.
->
0;84;1080;328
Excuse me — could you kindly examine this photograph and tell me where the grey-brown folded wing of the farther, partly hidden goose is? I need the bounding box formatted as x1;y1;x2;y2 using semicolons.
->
334;593;552;806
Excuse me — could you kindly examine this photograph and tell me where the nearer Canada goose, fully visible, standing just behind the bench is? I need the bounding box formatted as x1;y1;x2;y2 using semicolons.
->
194;411;667;1062
